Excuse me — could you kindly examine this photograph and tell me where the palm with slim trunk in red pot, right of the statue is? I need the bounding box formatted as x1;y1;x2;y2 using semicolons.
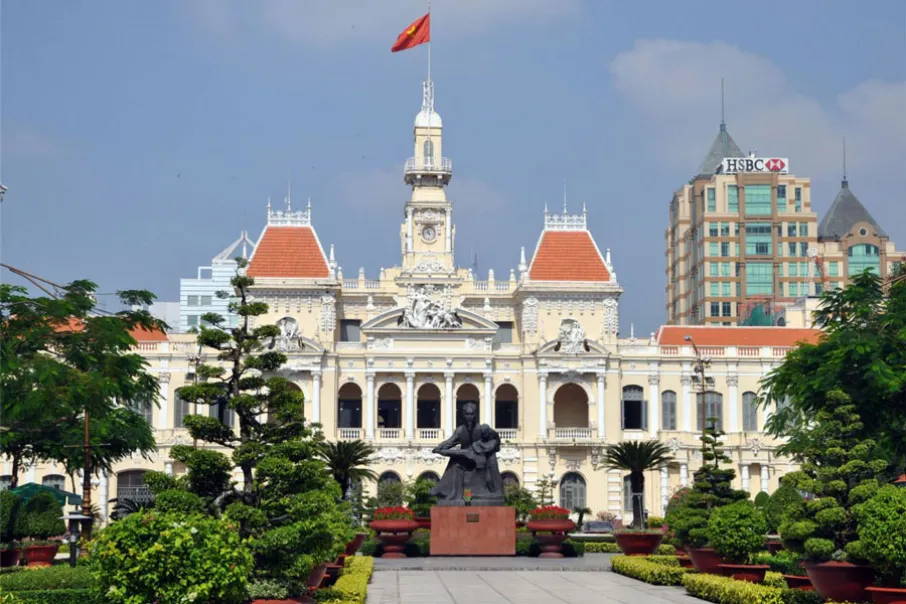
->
603;440;673;556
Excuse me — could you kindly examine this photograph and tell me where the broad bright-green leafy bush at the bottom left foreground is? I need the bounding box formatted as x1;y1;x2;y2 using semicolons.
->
92;510;252;604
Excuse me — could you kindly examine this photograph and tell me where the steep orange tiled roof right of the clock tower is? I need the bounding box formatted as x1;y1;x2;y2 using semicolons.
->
529;230;610;281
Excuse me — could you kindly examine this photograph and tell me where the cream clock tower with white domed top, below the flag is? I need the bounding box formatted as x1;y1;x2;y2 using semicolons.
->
401;80;456;275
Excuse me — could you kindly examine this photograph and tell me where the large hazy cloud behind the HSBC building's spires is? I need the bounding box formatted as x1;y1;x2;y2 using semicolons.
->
610;39;906;180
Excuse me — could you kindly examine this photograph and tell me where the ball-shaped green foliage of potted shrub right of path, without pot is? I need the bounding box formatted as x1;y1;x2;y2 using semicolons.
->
708;499;768;564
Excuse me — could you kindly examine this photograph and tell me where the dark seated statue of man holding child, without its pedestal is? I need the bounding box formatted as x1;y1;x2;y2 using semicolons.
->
431;403;504;506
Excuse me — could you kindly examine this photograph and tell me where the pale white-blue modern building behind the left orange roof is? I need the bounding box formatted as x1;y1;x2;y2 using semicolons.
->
179;231;255;332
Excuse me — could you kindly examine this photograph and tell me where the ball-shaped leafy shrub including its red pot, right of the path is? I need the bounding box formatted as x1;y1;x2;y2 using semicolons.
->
708;499;771;583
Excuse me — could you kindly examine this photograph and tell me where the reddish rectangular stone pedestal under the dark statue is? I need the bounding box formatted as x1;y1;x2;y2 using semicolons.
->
431;506;516;556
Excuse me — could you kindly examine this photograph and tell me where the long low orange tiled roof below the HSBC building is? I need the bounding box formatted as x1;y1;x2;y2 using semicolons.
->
656;325;821;347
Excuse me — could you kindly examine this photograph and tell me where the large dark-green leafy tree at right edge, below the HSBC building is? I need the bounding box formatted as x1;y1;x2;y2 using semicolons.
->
759;266;906;472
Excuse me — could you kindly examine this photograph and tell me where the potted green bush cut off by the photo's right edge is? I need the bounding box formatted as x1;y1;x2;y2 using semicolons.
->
851;485;906;604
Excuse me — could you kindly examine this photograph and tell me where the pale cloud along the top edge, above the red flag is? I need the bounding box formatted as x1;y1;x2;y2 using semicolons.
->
188;0;580;48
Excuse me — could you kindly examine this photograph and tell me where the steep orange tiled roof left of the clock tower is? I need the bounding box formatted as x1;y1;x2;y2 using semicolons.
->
247;226;328;279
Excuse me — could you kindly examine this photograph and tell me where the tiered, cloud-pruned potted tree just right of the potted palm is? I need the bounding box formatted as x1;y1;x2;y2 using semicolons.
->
666;419;748;574
